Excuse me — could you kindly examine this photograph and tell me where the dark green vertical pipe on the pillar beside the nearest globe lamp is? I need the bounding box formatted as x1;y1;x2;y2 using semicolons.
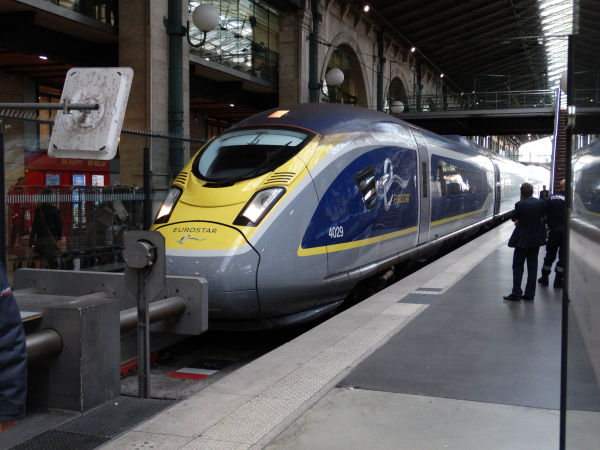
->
167;0;187;178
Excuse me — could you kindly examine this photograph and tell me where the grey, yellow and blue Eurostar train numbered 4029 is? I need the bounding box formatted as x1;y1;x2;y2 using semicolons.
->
153;104;525;328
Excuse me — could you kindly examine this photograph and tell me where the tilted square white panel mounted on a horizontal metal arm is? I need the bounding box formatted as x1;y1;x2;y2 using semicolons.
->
48;67;133;160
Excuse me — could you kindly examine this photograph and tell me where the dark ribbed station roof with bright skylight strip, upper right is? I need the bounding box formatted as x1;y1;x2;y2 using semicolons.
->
371;0;573;92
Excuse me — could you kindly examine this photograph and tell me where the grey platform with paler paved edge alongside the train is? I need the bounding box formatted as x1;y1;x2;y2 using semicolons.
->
103;222;600;450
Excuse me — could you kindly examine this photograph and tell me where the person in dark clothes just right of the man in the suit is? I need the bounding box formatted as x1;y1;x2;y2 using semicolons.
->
538;180;565;288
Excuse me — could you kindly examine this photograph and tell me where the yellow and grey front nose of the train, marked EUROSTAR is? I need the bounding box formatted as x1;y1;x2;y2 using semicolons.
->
157;221;259;320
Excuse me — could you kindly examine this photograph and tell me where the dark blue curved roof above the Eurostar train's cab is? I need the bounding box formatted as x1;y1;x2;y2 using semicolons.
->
232;103;410;135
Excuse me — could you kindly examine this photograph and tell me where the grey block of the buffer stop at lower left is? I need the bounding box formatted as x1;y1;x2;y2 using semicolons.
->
15;291;120;412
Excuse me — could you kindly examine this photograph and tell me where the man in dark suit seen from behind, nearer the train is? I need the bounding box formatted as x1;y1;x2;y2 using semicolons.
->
504;183;546;301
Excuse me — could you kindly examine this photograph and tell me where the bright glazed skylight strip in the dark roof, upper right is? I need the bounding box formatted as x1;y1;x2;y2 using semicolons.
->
538;0;573;88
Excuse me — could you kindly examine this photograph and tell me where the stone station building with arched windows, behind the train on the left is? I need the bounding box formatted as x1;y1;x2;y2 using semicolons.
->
0;0;516;267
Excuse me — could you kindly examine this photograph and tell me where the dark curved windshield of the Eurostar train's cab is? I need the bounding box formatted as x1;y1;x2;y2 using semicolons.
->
193;128;312;184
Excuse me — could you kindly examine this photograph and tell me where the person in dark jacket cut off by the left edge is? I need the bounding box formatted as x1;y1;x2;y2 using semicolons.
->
0;265;27;433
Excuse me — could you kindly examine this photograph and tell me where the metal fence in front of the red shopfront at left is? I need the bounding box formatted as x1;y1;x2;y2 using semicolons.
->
6;185;144;271
